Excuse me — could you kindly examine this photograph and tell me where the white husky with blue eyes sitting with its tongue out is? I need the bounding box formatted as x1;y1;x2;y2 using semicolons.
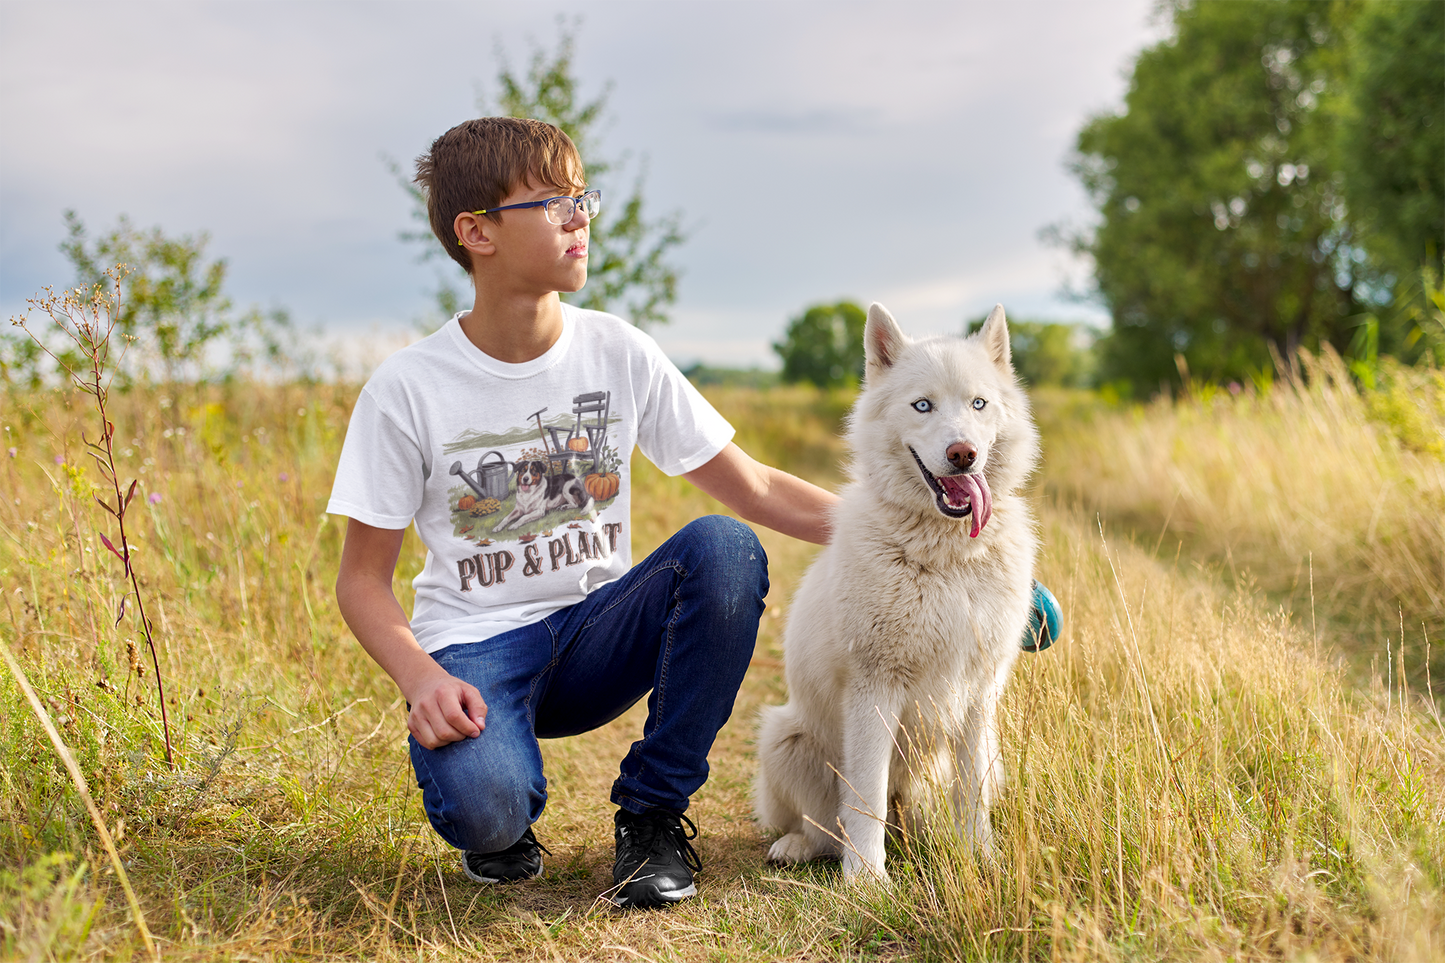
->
756;304;1039;879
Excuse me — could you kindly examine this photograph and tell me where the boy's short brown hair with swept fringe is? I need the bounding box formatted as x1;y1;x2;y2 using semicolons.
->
416;117;587;273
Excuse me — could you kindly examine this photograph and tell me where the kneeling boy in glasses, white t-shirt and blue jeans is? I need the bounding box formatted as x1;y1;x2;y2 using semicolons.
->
328;117;837;907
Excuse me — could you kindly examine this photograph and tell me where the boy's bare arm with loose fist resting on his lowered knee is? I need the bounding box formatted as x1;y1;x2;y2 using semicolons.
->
337;519;487;749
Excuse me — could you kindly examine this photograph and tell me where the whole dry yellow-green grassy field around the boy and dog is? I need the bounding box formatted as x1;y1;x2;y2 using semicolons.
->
0;372;1445;960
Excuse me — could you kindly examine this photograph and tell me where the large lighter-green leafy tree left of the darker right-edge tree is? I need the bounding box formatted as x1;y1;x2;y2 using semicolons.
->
1072;0;1375;388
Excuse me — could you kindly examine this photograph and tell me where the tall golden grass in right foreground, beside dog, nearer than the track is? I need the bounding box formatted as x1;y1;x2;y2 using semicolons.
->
912;513;1445;959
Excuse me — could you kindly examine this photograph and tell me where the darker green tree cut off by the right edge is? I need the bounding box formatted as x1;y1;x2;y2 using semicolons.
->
1340;0;1445;279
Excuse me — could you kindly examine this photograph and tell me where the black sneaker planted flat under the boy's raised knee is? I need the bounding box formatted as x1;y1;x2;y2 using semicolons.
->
613;810;702;908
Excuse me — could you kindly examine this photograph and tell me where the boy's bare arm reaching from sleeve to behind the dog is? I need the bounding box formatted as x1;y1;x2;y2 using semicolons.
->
682;441;838;545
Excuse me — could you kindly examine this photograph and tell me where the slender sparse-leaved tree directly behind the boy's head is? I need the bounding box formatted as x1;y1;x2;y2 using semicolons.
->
389;26;686;327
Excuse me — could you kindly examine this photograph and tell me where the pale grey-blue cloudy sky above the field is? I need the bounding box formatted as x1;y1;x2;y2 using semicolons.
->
0;0;1159;367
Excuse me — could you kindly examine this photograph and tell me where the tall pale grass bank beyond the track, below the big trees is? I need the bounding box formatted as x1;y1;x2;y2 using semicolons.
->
1040;353;1445;684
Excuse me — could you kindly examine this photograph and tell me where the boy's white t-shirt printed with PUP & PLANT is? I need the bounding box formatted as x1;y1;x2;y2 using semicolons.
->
327;304;733;652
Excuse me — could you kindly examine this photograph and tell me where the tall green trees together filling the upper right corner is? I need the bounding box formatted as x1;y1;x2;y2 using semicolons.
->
1064;0;1445;393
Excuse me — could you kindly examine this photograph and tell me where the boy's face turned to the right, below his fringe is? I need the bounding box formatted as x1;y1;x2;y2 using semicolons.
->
473;184;591;295
